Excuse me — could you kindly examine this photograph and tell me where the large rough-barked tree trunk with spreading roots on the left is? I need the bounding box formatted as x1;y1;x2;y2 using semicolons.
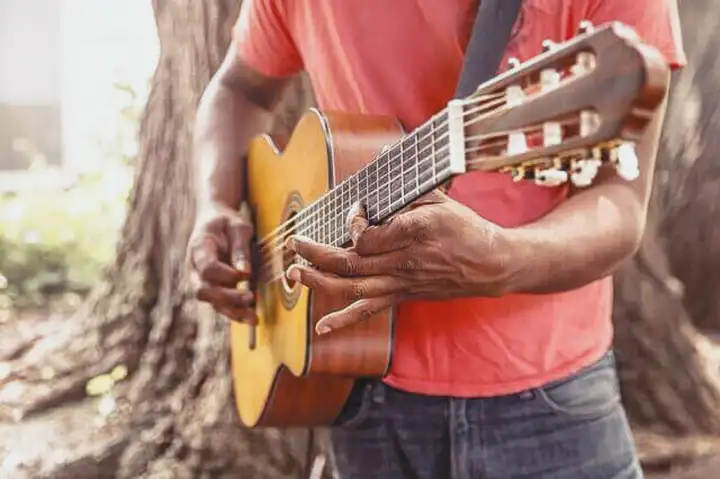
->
1;0;320;478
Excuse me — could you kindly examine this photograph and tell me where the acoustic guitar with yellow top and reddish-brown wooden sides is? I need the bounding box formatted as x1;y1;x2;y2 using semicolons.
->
230;23;670;427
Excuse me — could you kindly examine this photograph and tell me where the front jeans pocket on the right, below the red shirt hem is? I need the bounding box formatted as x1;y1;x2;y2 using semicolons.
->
537;352;620;418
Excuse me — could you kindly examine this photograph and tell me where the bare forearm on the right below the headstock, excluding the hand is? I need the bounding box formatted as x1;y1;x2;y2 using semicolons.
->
504;79;667;293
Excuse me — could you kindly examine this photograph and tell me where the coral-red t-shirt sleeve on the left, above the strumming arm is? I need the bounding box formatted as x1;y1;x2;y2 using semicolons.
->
233;0;303;77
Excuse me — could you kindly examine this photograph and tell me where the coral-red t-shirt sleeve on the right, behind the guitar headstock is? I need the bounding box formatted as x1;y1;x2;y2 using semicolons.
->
585;0;687;69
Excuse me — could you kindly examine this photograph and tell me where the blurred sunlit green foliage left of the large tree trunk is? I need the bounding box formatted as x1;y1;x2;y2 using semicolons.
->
0;74;146;311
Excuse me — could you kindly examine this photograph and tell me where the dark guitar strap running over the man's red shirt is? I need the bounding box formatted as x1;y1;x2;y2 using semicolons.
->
455;0;522;98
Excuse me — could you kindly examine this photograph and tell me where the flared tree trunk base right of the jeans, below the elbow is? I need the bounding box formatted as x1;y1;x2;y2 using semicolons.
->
614;212;720;434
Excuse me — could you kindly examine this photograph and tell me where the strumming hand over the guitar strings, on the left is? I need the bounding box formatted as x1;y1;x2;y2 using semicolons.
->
187;204;256;324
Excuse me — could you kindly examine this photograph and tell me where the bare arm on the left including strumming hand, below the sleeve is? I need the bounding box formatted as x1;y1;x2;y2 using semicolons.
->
188;45;296;322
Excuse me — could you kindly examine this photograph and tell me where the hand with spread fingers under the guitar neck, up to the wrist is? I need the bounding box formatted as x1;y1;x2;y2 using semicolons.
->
287;192;512;334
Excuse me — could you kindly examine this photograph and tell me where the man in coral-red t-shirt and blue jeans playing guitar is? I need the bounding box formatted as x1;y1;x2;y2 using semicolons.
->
189;0;684;479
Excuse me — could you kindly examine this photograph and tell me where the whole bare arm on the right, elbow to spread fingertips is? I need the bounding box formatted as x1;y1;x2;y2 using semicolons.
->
287;79;665;334
